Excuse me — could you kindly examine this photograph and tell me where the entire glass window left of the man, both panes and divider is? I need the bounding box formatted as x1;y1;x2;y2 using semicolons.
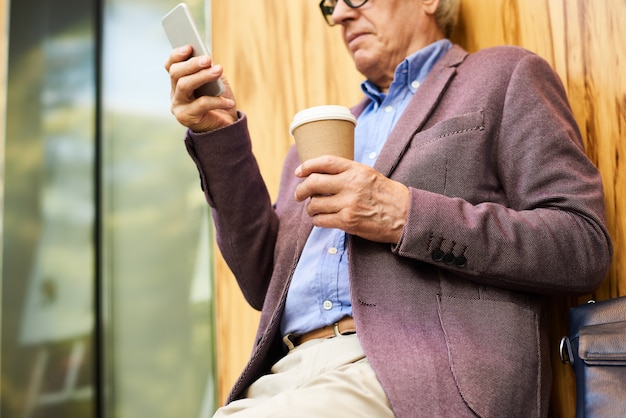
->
0;0;216;418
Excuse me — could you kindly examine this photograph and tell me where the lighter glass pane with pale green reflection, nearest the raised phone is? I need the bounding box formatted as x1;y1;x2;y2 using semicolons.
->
102;0;215;418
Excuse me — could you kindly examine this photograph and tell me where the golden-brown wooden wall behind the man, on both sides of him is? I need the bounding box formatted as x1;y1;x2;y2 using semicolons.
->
212;0;626;417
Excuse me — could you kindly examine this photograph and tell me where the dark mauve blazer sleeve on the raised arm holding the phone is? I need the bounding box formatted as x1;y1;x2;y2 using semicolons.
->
185;114;278;310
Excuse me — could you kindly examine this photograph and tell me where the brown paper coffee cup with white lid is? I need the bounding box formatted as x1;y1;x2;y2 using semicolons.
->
289;105;356;162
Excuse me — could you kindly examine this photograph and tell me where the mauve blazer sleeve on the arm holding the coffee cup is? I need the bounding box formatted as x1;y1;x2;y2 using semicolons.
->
392;53;612;293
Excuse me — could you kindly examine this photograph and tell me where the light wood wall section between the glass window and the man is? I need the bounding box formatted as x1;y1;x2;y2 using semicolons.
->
212;0;361;402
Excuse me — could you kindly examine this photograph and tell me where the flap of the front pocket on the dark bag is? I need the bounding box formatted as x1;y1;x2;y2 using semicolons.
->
578;321;626;366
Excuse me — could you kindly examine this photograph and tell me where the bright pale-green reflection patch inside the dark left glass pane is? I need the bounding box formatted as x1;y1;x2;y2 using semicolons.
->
20;32;94;350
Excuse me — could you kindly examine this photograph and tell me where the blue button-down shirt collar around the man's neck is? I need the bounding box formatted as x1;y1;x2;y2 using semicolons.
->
361;39;452;105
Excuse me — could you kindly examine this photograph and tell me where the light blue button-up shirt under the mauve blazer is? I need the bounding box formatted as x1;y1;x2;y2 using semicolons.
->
281;39;452;335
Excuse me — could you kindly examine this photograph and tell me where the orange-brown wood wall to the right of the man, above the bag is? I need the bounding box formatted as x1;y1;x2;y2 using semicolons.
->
455;0;626;417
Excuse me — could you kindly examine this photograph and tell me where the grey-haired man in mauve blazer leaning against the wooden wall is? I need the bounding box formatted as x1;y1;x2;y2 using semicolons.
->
165;0;612;418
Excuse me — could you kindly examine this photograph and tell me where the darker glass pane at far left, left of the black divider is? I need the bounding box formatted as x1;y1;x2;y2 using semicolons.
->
1;2;95;417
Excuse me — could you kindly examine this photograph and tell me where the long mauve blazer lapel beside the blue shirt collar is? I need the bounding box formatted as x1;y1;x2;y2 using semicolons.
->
374;45;468;177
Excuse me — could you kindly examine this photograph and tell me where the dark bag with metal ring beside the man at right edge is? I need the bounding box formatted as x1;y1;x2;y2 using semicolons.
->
560;296;626;418
